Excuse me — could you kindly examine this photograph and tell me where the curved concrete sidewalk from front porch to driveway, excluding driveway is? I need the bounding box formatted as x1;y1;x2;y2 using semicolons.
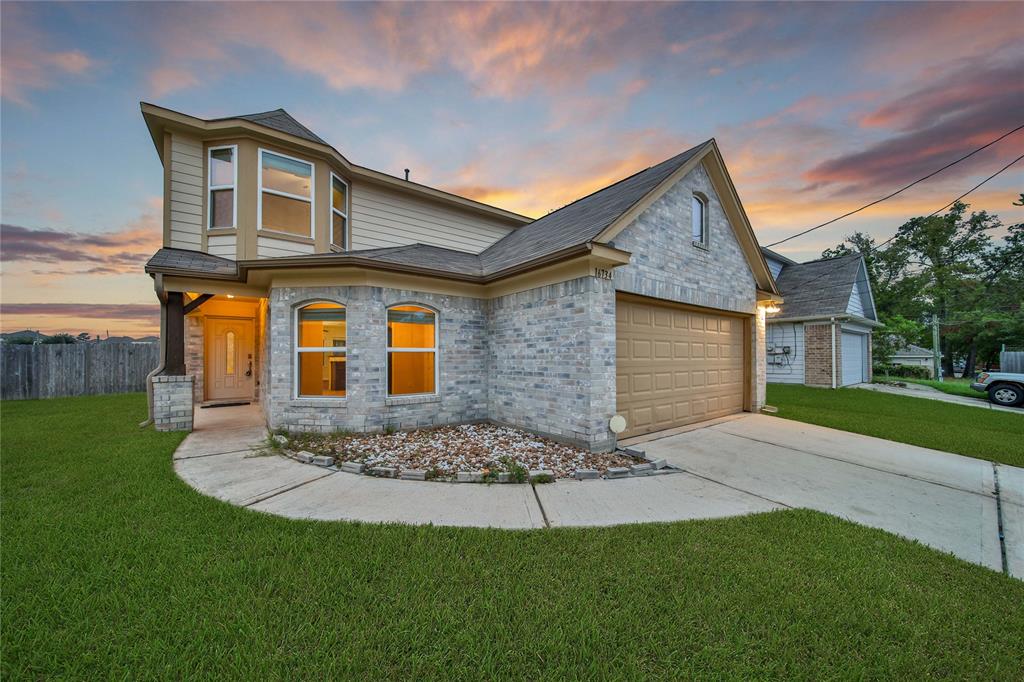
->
174;406;784;528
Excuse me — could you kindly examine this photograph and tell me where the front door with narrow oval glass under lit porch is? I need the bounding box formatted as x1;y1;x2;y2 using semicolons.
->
206;317;256;400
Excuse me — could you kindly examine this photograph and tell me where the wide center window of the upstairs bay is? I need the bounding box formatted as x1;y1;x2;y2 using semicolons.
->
259;150;313;238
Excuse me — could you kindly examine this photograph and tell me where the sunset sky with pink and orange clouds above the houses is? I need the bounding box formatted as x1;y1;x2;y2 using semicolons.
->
0;2;1024;336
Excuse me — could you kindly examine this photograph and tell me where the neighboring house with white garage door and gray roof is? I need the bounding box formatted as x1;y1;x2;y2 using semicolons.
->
761;248;881;388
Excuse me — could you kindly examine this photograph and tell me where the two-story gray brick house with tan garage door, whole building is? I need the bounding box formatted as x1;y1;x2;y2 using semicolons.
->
142;103;780;451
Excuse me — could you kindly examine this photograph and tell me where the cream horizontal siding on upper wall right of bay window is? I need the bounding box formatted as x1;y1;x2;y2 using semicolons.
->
351;183;512;253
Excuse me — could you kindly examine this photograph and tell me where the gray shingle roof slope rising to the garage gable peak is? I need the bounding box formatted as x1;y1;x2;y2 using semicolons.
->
480;142;707;273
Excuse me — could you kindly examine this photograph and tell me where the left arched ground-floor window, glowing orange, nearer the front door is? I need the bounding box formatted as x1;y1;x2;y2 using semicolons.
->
295;302;346;397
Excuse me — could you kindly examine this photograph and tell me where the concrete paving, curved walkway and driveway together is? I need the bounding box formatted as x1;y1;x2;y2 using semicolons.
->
174;407;1024;578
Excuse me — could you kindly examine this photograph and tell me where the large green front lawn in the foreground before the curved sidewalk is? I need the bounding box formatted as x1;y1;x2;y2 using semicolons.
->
6;395;1024;680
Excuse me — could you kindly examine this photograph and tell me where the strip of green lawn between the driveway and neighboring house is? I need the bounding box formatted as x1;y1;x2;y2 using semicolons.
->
768;384;1024;467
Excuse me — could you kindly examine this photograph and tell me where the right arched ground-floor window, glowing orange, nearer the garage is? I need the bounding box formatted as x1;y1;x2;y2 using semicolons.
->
387;305;437;395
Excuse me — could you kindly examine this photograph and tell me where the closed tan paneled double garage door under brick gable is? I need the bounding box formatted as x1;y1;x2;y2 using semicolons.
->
615;296;749;437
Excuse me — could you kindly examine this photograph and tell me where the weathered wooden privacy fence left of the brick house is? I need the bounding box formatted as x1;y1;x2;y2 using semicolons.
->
0;343;160;400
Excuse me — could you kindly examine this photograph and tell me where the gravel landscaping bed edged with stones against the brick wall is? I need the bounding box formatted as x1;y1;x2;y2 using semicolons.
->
276;424;637;481
